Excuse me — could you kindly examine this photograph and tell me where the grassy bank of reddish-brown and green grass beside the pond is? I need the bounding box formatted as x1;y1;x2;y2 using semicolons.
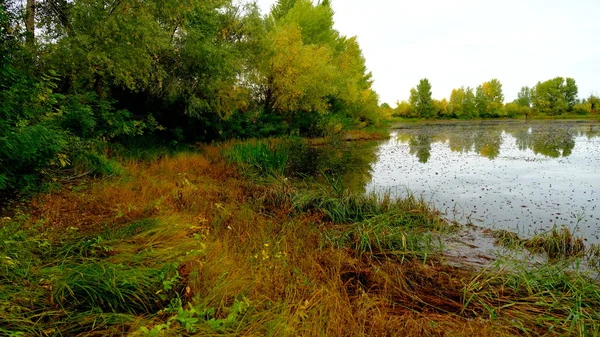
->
0;140;600;336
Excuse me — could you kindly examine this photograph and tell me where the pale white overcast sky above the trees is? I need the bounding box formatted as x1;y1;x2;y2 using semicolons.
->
257;0;600;106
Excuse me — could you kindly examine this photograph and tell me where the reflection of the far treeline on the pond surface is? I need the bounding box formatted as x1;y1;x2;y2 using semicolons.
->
398;122;600;163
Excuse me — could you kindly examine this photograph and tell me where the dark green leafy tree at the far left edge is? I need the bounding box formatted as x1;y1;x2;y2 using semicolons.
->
0;3;67;191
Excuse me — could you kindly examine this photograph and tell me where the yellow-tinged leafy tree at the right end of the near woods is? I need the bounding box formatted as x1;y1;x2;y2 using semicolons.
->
251;0;382;133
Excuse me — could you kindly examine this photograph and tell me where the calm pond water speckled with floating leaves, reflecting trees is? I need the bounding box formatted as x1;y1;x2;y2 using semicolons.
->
366;121;600;242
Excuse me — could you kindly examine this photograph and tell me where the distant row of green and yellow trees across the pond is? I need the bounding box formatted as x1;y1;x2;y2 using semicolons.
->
394;77;600;119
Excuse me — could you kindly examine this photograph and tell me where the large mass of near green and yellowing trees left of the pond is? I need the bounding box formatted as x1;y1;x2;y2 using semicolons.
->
0;0;387;192
